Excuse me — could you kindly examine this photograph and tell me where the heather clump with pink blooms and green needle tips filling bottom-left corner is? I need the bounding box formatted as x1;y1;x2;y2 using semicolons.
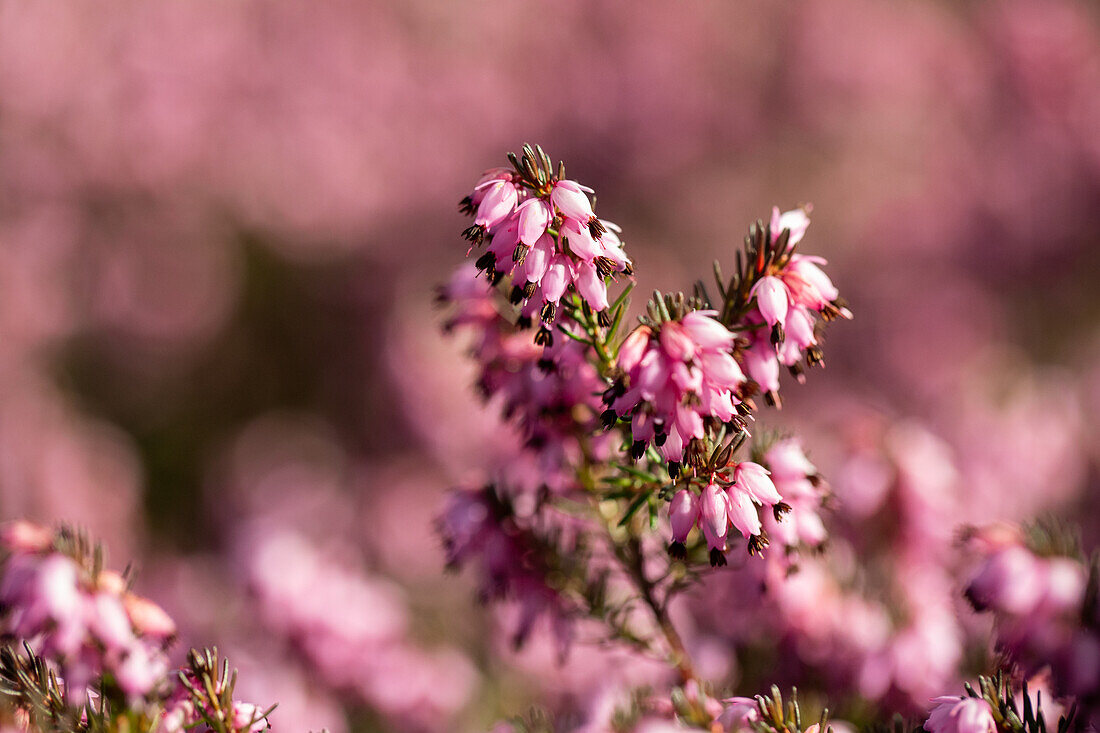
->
0;522;274;733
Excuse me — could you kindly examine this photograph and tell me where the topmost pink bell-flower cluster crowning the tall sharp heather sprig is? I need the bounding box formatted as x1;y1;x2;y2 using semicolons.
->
460;145;633;344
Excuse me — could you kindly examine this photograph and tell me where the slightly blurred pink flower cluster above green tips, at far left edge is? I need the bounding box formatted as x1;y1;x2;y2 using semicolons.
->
0;522;176;698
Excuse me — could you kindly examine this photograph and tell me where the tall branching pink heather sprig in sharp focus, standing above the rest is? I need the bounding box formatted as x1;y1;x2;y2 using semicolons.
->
439;145;850;681
